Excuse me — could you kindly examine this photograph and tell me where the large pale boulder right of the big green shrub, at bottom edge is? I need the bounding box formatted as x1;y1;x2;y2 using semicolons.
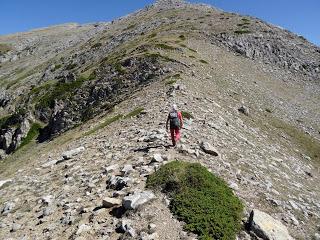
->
248;209;293;240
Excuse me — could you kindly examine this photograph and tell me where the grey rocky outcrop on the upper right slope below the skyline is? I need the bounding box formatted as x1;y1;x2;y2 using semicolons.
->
213;30;320;79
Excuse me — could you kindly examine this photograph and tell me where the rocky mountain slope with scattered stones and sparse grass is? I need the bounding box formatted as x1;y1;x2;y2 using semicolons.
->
0;0;320;239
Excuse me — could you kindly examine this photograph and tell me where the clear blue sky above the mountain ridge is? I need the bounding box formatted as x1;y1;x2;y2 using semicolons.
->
0;0;320;46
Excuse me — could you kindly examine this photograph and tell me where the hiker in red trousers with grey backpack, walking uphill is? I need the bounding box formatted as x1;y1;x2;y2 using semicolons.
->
166;104;183;146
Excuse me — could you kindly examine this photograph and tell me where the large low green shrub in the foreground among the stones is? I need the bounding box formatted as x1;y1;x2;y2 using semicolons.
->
147;161;243;240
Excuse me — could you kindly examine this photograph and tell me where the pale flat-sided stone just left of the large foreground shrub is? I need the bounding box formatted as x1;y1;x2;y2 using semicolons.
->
122;191;155;209
